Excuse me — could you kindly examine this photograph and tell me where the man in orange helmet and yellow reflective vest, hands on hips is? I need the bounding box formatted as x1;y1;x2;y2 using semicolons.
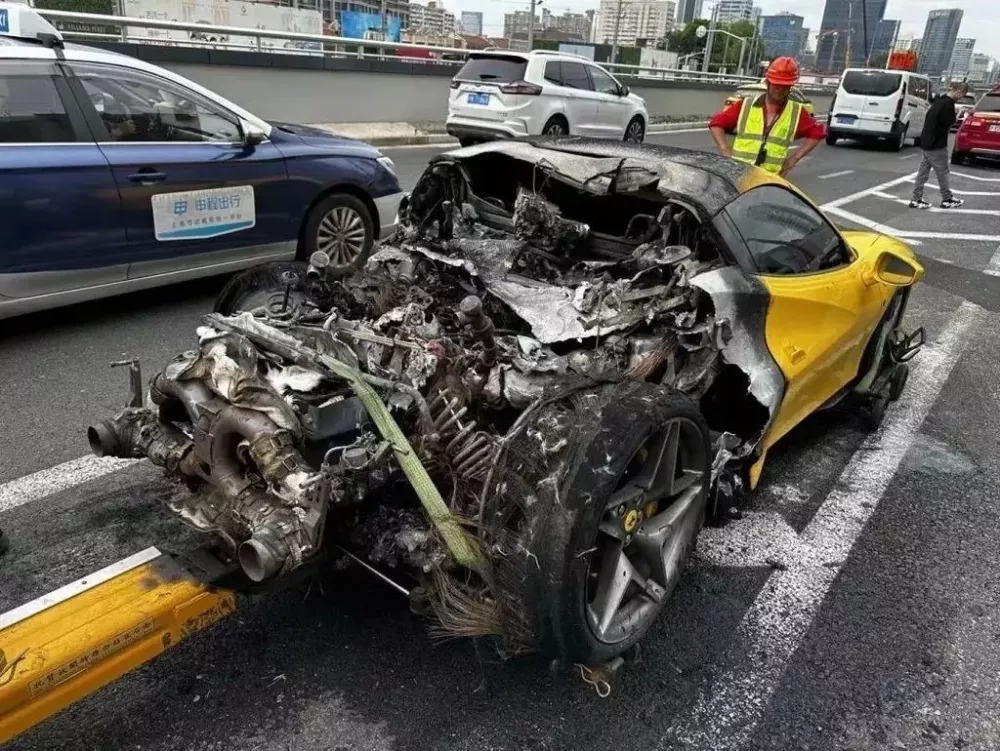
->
708;57;826;177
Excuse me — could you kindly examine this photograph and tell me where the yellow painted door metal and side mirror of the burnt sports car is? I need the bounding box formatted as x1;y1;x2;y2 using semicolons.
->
752;228;923;452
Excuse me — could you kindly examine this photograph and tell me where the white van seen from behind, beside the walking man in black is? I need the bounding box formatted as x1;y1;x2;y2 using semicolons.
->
826;68;932;151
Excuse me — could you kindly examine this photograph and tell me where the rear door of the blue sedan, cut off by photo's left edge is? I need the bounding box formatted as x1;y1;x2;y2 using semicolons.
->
0;59;128;298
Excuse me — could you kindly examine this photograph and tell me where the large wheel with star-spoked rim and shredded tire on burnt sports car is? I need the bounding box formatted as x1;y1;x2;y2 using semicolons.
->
512;382;711;664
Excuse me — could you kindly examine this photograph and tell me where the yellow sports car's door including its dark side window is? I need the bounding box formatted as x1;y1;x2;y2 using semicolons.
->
725;185;893;448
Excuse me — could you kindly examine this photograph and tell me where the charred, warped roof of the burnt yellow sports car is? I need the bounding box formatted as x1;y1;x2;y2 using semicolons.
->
432;136;772;217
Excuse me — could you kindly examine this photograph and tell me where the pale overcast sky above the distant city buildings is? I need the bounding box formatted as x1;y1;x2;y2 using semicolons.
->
446;0;1000;58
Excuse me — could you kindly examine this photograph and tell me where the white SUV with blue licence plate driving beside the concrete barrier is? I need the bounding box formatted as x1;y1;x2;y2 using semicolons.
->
445;50;649;146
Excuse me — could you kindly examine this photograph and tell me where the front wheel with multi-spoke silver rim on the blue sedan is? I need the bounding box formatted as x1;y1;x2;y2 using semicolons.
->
300;193;375;275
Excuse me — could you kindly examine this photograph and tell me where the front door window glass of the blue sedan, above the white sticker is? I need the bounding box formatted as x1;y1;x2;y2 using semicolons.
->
73;63;240;143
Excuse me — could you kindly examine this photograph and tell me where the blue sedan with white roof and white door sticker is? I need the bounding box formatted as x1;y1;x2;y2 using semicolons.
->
0;6;402;318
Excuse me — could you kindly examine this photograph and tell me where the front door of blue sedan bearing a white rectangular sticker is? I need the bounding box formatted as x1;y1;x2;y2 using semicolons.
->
68;62;292;279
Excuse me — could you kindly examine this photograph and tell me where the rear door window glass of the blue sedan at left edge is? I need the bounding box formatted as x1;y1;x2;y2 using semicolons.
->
0;63;77;143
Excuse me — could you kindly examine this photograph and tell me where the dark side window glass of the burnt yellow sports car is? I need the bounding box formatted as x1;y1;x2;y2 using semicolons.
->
725;185;850;275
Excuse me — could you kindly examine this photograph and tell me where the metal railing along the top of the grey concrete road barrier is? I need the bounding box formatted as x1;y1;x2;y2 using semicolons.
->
37;8;840;89
